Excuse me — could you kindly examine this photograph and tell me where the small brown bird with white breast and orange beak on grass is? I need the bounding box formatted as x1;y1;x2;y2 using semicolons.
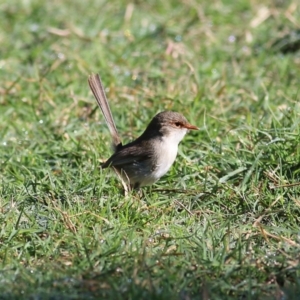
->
88;74;198;191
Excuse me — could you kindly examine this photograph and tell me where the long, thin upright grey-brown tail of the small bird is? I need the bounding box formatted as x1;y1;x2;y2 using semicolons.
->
88;74;122;150
